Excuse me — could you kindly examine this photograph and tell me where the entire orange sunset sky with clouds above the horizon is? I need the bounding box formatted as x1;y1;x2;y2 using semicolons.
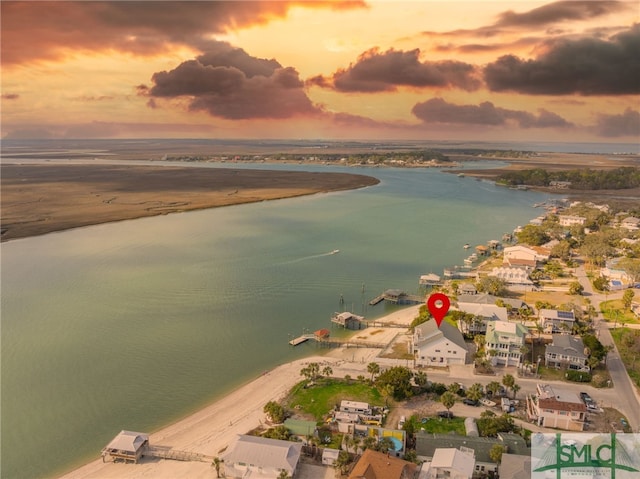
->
0;0;640;143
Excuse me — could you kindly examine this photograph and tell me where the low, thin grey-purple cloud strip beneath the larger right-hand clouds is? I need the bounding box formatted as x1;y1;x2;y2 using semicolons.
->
411;98;572;128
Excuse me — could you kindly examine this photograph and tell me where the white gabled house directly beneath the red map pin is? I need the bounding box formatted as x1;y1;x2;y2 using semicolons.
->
412;320;467;366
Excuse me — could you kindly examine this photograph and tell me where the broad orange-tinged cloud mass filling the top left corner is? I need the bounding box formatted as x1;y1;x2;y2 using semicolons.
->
0;0;364;65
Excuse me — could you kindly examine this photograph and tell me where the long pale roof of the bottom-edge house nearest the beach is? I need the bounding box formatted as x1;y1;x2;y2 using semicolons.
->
224;435;302;471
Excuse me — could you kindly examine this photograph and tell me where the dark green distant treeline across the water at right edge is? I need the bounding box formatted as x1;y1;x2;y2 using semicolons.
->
497;167;640;190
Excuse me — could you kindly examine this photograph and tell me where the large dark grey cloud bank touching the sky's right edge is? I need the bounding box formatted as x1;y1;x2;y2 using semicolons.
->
484;25;640;95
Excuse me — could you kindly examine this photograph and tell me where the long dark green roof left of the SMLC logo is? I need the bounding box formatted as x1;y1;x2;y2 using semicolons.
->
416;431;531;463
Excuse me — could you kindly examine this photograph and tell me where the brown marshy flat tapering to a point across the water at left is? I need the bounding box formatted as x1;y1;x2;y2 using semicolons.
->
0;162;379;241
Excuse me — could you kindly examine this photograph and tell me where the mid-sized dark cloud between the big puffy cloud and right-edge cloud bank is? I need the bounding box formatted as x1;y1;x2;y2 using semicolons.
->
310;48;481;93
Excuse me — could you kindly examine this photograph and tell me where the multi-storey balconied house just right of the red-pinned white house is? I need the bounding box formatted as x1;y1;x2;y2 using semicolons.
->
485;321;529;366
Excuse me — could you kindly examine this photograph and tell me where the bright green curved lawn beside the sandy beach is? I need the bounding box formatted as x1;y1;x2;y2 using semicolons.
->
287;378;384;421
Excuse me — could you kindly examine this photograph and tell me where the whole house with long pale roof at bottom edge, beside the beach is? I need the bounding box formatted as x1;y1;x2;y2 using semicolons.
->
223;435;302;479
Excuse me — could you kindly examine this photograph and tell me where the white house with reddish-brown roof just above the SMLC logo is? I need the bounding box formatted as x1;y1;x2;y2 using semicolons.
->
527;384;587;431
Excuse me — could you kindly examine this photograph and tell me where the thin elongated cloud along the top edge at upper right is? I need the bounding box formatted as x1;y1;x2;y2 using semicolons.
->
495;0;629;27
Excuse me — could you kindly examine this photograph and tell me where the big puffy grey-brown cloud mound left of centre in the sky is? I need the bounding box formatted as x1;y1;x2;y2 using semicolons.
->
149;42;320;120
